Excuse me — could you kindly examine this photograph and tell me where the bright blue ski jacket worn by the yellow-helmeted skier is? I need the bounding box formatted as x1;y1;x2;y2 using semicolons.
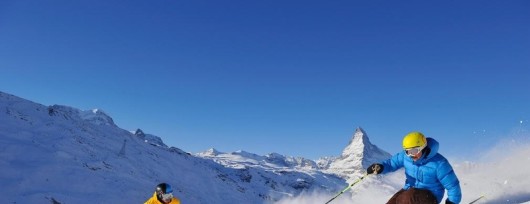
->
382;138;462;203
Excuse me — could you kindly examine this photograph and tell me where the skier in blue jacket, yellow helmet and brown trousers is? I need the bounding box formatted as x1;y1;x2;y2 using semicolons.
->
367;132;462;204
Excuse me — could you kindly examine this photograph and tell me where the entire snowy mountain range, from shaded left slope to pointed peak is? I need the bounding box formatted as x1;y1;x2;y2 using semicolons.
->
0;92;390;204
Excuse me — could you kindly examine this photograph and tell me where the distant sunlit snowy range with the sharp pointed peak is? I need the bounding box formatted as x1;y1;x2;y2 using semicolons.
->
196;127;391;182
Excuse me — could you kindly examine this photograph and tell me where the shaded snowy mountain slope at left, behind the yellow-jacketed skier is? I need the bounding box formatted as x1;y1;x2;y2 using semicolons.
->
0;93;263;203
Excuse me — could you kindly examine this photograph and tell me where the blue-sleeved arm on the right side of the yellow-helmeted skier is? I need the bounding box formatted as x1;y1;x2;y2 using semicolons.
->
436;161;462;203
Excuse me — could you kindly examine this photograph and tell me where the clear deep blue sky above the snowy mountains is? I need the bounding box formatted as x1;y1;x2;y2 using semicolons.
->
0;0;530;159
